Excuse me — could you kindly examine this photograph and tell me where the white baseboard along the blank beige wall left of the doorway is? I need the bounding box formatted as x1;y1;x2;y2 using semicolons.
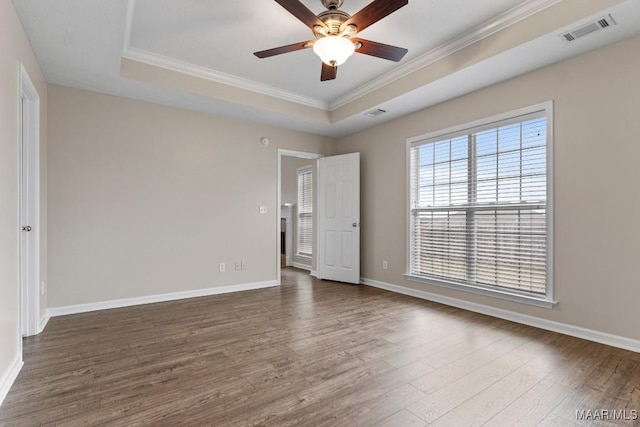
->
48;280;278;317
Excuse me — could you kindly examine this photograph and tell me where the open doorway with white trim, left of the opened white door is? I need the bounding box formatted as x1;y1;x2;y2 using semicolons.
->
276;149;323;285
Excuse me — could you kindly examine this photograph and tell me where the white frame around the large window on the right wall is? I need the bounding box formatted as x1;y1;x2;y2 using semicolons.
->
404;101;556;308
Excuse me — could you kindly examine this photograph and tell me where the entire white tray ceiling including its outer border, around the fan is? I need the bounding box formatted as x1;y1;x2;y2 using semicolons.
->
14;0;640;137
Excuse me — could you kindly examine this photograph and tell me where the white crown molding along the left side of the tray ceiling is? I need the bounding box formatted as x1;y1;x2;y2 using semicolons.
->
122;47;329;111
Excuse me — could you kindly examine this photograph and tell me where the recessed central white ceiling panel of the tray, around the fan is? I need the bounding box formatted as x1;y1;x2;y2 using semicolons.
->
130;0;522;102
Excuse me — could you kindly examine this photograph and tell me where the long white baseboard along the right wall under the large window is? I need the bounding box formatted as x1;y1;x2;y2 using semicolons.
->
361;278;640;353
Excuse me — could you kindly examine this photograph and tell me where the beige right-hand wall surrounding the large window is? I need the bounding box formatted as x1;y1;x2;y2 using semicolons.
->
337;33;640;339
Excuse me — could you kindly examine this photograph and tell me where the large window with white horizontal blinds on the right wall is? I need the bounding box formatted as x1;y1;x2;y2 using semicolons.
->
408;104;553;307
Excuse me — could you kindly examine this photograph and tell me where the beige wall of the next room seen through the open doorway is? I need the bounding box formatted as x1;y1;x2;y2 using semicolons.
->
281;156;318;271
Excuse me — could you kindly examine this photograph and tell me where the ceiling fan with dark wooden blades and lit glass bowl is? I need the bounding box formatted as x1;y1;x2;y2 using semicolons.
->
254;0;409;81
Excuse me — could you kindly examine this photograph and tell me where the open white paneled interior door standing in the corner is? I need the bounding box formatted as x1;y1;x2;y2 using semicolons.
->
317;153;360;283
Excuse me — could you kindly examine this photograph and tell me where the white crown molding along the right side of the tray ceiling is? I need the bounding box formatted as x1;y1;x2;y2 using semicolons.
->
329;0;562;111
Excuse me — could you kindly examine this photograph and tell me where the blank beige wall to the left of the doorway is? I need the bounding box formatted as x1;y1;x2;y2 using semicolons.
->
49;86;334;307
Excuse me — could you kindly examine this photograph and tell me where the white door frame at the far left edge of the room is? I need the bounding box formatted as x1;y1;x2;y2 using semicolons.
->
18;63;42;336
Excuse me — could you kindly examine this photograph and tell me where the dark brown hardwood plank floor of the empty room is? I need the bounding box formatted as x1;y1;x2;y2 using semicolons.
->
0;269;640;427
